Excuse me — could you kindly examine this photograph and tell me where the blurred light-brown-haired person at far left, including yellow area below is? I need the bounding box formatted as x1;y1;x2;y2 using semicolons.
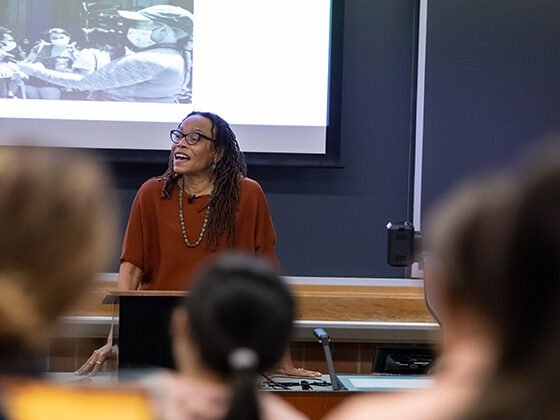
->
0;147;149;420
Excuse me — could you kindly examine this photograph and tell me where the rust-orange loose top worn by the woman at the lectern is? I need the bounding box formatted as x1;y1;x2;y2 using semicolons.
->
121;178;277;290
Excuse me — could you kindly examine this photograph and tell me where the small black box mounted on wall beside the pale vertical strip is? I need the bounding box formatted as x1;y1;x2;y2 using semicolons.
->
387;222;422;267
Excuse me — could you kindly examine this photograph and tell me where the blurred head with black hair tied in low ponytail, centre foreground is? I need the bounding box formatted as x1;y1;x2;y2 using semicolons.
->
172;254;294;419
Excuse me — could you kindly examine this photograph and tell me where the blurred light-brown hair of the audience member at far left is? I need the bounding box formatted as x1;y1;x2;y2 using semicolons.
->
0;147;115;355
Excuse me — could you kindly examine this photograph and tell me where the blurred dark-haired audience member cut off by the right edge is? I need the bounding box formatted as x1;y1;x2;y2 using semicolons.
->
464;146;560;420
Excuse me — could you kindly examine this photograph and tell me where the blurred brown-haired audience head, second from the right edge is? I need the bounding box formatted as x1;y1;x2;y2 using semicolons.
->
424;175;511;328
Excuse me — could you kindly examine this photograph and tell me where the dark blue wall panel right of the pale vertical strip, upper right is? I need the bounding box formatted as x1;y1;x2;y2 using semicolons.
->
422;0;560;216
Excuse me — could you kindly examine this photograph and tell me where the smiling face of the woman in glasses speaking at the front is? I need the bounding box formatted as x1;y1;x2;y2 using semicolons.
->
171;115;216;177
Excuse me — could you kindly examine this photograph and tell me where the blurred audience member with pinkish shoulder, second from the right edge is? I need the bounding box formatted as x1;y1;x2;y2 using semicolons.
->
327;177;501;420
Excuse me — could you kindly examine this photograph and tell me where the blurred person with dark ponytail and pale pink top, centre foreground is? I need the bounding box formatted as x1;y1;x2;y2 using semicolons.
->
146;254;305;420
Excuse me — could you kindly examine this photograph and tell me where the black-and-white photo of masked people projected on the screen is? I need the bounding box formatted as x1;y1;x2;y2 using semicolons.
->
0;0;193;103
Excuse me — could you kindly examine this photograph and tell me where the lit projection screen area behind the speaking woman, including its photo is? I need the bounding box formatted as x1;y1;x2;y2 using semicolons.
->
0;0;332;156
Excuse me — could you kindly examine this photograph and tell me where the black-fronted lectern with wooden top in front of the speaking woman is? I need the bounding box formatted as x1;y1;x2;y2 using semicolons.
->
103;290;187;371
